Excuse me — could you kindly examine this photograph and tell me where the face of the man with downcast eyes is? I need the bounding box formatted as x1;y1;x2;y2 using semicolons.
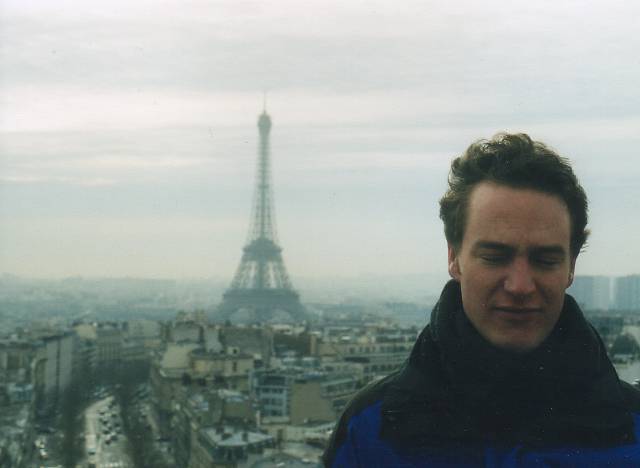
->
449;182;575;352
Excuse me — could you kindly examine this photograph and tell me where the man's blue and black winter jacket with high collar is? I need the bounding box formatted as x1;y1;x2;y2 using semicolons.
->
323;283;640;468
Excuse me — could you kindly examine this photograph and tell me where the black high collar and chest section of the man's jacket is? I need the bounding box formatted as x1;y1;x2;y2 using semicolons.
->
381;282;635;446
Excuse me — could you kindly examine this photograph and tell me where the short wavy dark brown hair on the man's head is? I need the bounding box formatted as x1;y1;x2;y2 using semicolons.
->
440;133;589;257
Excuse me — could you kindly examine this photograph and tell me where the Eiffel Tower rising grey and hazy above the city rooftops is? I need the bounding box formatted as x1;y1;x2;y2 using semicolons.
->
216;110;306;323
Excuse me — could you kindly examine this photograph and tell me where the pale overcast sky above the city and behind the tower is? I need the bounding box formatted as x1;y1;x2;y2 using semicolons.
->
0;0;640;285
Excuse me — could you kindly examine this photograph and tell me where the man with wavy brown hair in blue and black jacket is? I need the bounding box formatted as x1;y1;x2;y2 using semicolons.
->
324;134;640;467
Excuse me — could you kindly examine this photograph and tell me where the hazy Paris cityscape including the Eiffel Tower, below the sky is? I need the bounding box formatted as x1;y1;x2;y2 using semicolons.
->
0;110;640;468
